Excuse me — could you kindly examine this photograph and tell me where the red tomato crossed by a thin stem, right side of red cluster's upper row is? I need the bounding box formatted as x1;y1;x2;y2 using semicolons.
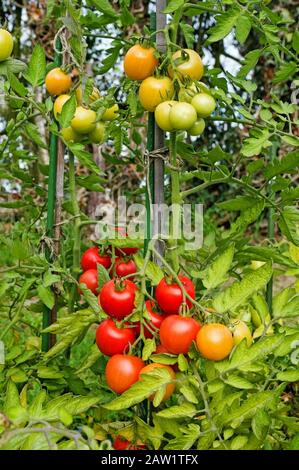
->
156;274;195;315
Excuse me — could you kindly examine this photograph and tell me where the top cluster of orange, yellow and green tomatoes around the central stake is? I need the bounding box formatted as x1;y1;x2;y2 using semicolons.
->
124;44;216;136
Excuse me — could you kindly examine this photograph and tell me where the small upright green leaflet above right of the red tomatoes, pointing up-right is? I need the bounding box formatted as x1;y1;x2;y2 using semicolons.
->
201;245;235;289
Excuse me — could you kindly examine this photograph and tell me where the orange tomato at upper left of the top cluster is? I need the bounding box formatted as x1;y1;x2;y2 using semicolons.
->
124;44;158;80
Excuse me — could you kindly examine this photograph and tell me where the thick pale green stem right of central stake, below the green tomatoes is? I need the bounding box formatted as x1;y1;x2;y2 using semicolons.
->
169;132;182;273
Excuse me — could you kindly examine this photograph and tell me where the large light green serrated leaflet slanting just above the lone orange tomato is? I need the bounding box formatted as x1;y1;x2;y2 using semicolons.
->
213;263;272;313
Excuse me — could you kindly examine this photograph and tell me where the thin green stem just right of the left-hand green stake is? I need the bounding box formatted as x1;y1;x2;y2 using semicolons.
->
68;152;81;313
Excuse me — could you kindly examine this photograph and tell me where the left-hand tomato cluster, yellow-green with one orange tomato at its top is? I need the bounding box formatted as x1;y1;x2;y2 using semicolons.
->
45;67;119;144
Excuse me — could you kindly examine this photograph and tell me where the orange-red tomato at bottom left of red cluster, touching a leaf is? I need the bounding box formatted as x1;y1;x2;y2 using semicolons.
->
105;354;144;393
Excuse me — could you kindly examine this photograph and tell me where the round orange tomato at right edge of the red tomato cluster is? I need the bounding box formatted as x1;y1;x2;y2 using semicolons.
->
196;323;234;361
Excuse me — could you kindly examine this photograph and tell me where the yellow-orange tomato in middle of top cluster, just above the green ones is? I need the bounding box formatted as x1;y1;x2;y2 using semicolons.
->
139;77;174;112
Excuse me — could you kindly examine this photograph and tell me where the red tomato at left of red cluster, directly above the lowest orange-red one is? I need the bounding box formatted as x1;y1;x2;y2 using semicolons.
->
96;319;135;356
